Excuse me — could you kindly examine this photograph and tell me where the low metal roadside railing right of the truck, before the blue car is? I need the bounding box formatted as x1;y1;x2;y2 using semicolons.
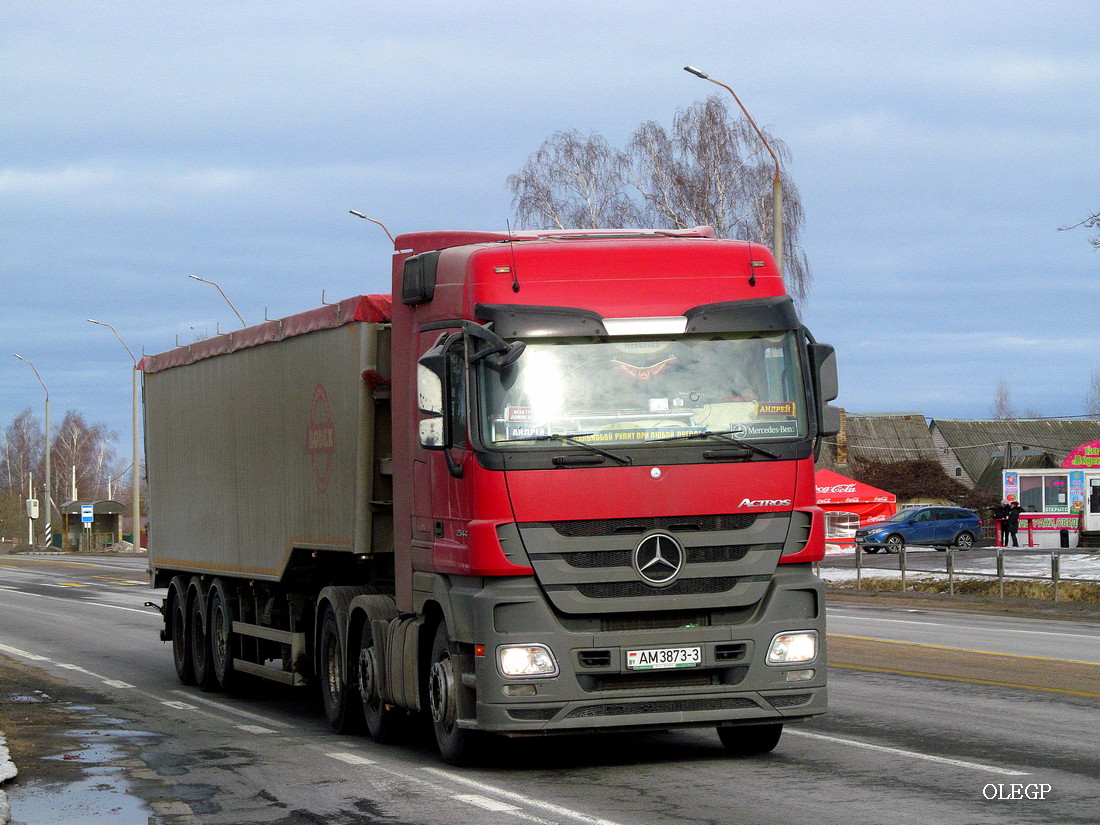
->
815;547;1100;602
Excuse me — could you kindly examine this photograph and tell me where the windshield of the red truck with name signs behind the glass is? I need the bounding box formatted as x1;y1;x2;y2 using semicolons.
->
479;332;807;449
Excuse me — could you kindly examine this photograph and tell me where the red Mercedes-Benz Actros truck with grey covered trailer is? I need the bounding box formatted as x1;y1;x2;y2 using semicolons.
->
142;228;837;765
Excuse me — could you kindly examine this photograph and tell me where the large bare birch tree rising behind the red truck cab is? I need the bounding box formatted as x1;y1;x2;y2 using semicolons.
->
508;96;812;300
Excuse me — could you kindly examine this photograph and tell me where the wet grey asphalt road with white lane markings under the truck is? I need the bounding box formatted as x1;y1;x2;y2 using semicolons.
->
0;557;1100;825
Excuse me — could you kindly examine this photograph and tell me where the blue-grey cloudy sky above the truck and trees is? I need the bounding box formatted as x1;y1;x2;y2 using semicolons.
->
0;0;1100;457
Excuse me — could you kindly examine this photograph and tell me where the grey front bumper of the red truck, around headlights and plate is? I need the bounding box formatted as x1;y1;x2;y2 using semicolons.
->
452;564;827;736
